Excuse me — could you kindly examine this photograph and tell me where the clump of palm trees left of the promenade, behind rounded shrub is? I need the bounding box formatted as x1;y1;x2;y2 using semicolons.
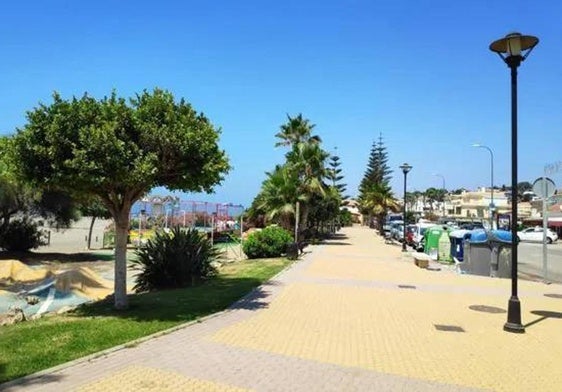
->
248;114;342;237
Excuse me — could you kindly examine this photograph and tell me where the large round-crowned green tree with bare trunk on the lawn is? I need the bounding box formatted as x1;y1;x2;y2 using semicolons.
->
8;89;230;309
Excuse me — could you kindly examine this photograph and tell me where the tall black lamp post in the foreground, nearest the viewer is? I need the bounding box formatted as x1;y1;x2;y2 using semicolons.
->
490;33;539;333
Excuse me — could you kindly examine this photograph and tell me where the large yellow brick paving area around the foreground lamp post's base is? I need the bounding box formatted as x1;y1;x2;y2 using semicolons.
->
210;229;562;391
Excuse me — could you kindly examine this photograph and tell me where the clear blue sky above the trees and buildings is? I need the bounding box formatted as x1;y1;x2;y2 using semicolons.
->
0;0;562;206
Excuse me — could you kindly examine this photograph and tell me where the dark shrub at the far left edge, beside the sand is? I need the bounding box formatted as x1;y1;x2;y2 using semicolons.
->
0;217;47;251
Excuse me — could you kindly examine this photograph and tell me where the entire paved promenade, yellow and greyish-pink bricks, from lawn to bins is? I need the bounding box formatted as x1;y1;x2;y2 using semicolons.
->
0;228;562;391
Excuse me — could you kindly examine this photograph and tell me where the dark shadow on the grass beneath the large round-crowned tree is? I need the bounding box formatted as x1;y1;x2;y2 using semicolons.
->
68;276;277;322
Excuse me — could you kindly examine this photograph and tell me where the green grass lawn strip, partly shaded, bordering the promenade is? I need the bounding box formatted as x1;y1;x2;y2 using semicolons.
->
0;259;290;382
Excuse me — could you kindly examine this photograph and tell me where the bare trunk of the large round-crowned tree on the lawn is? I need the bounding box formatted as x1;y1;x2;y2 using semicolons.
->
114;208;130;310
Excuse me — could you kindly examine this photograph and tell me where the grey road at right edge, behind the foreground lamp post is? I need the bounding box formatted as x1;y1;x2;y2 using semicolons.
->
519;241;562;283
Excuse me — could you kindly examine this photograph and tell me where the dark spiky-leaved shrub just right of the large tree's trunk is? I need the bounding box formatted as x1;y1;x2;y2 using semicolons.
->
131;228;221;292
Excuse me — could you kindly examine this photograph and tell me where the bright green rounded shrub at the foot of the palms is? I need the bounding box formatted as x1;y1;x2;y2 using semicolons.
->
242;226;293;259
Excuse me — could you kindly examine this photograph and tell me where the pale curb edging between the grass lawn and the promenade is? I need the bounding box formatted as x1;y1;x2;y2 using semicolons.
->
0;259;299;391
